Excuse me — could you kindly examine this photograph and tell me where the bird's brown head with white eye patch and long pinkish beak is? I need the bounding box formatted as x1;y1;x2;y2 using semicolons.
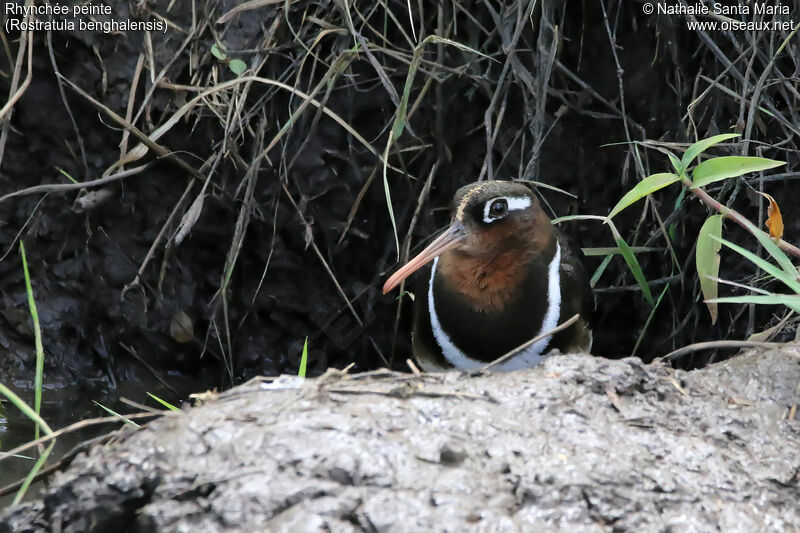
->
383;181;554;294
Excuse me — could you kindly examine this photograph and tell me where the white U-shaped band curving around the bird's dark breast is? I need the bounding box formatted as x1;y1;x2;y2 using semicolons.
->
428;240;561;372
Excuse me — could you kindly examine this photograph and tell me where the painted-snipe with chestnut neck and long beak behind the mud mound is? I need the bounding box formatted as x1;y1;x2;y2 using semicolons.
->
383;180;594;372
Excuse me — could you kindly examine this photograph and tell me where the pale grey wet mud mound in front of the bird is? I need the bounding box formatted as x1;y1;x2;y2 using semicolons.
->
0;344;800;533
